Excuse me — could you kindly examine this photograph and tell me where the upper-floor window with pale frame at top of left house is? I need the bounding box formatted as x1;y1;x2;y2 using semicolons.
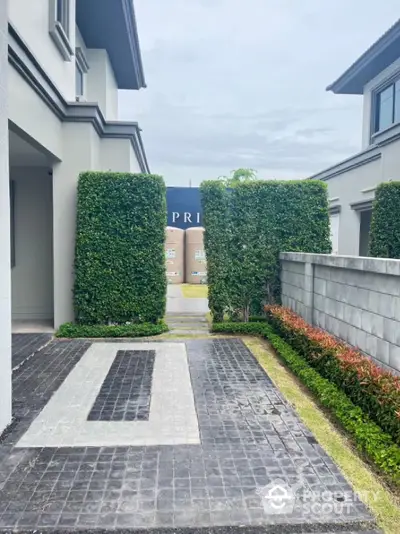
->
49;0;74;61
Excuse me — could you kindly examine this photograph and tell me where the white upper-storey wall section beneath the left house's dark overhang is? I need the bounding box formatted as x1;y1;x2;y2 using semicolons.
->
86;48;118;121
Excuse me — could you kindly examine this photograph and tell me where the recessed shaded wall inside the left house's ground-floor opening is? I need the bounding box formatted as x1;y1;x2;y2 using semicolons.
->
10;171;53;320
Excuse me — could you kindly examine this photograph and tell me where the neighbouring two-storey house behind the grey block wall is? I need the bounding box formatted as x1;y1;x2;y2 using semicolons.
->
311;21;400;256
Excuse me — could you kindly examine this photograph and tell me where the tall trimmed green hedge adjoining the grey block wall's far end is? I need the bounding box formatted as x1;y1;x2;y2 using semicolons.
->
201;180;331;321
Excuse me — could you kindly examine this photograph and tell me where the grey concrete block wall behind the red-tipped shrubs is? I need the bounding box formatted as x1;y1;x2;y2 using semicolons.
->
281;252;400;372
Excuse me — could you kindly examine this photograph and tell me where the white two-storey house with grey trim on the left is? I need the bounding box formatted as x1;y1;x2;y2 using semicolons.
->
0;0;149;431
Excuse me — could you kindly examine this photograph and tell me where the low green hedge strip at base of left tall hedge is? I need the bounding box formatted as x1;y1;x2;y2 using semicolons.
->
56;321;168;338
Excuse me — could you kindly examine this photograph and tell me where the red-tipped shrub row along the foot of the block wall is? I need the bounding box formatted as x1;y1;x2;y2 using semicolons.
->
267;306;400;444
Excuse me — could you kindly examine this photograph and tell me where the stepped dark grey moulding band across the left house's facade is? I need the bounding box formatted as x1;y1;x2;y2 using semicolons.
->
8;23;150;173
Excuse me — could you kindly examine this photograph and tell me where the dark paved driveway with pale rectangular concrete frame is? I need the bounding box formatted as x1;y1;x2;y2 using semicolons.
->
0;339;375;534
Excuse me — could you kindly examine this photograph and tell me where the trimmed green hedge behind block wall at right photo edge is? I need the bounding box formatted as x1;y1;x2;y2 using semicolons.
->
370;182;400;258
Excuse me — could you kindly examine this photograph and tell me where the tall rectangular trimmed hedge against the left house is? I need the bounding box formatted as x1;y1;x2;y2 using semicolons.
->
74;172;167;325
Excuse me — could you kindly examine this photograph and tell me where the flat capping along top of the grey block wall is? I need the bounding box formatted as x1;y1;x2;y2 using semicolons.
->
280;252;400;276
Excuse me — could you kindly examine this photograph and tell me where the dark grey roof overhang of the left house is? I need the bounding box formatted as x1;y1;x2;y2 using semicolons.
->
76;0;146;89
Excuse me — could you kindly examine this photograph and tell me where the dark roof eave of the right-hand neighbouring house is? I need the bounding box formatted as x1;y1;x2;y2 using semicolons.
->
327;20;400;95
